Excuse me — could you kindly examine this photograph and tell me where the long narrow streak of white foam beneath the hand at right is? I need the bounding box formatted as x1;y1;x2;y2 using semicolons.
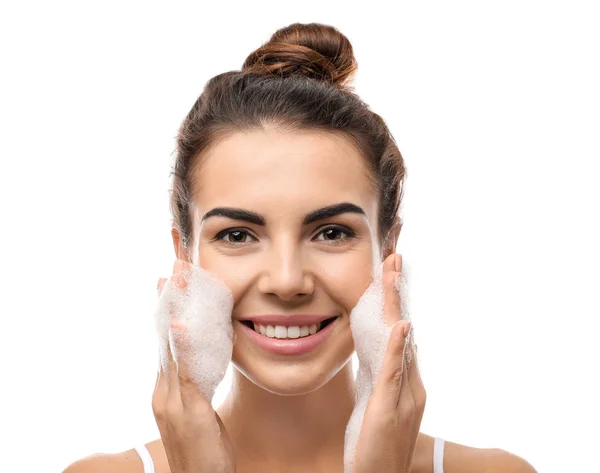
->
344;263;414;473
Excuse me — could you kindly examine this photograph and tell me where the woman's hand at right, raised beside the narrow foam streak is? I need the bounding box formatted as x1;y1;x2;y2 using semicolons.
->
352;255;427;473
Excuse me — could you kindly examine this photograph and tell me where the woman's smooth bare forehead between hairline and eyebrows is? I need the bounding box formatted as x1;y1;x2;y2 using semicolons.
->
194;127;376;216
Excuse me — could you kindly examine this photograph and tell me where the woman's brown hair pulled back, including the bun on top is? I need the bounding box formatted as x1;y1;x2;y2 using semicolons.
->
170;23;406;254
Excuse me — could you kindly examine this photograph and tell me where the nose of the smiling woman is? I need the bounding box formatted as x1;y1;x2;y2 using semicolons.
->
258;242;314;302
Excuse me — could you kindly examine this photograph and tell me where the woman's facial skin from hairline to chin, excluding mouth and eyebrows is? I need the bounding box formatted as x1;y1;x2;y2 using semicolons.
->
176;131;382;394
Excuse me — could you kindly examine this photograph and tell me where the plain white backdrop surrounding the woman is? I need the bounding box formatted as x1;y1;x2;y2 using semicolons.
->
0;0;600;473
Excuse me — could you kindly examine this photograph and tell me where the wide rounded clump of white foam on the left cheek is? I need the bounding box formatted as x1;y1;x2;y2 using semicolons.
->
155;265;235;401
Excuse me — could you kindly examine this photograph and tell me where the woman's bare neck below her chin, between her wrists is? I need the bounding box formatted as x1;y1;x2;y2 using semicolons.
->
217;360;356;471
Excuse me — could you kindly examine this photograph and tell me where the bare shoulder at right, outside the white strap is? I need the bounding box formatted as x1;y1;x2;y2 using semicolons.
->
444;441;537;473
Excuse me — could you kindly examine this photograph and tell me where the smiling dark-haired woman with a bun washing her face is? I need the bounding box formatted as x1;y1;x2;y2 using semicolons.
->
66;24;535;473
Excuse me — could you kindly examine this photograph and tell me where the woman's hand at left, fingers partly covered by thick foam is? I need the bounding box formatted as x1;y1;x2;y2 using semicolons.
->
152;260;235;473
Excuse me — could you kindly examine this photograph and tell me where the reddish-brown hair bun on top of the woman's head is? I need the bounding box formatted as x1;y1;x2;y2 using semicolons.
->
242;23;358;88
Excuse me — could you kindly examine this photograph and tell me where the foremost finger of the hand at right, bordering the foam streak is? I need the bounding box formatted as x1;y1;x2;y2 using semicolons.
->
373;320;410;409
